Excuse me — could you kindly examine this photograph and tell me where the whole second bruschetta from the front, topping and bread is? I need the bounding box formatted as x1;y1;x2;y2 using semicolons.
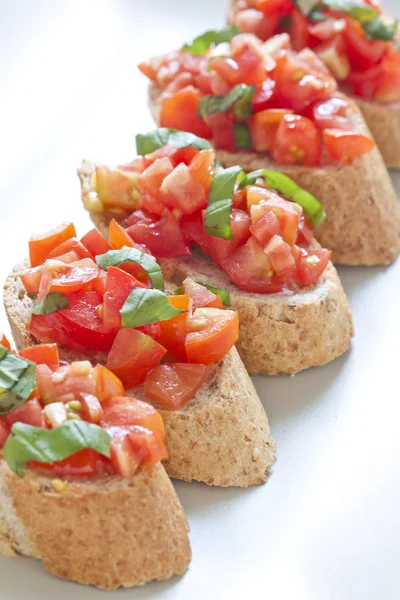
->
4;224;275;487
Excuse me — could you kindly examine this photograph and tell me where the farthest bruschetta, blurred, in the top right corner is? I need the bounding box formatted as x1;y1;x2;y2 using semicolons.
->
229;0;400;169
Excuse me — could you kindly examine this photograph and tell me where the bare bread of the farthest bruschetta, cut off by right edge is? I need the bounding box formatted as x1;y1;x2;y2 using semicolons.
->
228;0;400;169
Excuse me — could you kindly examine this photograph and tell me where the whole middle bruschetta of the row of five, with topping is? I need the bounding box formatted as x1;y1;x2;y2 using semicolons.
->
79;129;353;375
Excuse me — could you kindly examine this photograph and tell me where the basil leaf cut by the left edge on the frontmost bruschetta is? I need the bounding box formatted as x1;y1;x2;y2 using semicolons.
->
0;346;36;416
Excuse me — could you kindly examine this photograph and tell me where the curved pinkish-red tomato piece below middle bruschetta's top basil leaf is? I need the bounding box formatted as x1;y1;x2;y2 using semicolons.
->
139;156;174;215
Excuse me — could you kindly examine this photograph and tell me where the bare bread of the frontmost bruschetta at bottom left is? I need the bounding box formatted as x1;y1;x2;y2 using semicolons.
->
0;459;191;590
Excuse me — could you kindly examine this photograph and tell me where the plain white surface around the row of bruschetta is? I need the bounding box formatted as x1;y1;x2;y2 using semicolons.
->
0;0;400;600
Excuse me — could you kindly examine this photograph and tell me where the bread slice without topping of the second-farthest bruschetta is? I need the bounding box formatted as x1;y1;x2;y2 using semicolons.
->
149;84;400;265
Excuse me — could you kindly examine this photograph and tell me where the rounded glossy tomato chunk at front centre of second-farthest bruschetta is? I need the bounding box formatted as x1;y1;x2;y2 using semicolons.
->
272;115;321;167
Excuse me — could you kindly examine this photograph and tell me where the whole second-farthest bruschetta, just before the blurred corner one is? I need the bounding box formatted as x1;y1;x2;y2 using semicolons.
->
140;27;400;265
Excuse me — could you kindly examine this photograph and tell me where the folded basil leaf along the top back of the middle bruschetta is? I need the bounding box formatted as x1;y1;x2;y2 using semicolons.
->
136;127;214;156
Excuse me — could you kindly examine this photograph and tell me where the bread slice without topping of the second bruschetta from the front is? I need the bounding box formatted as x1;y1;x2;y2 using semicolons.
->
4;261;276;487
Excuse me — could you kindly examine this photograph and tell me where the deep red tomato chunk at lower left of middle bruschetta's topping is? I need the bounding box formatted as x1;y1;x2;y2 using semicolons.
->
126;209;190;258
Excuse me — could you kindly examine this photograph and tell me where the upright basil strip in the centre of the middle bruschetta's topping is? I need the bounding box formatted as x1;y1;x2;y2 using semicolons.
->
204;167;245;240
